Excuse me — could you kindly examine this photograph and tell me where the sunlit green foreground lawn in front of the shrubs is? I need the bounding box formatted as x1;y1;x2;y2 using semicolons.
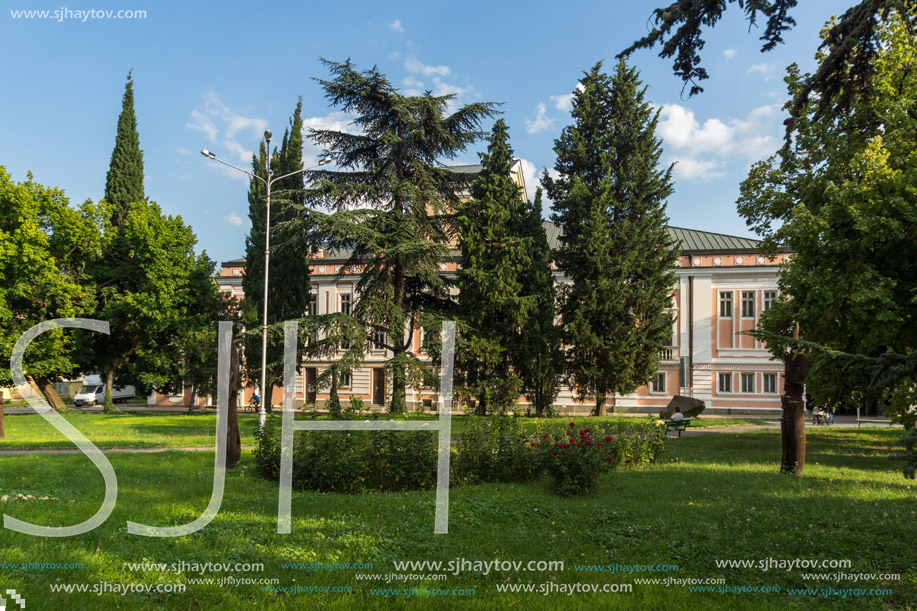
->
0;424;917;610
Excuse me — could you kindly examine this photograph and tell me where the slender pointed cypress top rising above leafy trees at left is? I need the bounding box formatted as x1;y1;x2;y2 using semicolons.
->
104;72;145;225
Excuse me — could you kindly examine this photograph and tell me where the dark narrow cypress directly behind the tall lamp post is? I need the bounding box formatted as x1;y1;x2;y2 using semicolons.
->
242;98;312;410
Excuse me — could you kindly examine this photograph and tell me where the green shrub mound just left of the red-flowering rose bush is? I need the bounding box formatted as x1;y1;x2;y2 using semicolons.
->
452;416;542;484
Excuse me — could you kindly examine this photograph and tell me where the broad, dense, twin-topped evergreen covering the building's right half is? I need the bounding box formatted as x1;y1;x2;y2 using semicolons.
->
543;61;678;415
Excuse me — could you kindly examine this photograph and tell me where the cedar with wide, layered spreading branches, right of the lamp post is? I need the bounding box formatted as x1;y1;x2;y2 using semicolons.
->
298;60;496;412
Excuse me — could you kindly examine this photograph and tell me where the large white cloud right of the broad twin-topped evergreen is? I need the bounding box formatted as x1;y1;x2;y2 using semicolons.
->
657;104;782;180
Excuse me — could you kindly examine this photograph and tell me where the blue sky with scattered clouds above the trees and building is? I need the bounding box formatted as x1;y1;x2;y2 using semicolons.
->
0;0;854;261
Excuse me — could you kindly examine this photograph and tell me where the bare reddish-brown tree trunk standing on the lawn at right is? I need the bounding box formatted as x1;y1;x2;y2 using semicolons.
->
780;351;809;475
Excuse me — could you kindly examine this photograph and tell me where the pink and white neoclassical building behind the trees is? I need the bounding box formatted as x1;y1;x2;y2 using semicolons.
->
208;162;789;414
